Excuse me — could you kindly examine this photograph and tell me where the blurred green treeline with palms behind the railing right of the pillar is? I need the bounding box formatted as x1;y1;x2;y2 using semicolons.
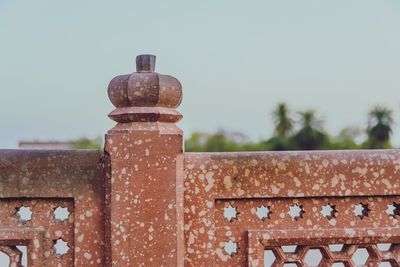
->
185;103;394;152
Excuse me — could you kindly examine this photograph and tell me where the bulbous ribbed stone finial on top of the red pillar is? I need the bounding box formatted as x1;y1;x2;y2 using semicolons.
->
108;55;182;123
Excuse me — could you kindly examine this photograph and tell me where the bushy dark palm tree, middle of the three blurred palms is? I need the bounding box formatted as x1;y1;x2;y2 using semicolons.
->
292;110;328;150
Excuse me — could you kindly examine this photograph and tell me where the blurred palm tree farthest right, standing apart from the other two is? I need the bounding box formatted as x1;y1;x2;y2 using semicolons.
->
367;106;393;148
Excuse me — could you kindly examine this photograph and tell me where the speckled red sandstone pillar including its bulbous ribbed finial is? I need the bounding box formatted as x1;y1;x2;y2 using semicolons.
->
105;55;184;266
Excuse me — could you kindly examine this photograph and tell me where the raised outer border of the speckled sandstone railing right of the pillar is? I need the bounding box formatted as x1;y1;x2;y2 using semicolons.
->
184;150;400;266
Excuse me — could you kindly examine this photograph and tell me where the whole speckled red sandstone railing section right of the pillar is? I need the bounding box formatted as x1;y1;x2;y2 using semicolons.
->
184;150;400;266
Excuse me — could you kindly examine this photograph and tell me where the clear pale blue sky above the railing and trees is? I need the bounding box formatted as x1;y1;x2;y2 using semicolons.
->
0;0;400;148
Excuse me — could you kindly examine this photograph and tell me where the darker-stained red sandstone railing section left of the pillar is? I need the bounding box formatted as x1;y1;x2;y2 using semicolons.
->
0;150;105;267
